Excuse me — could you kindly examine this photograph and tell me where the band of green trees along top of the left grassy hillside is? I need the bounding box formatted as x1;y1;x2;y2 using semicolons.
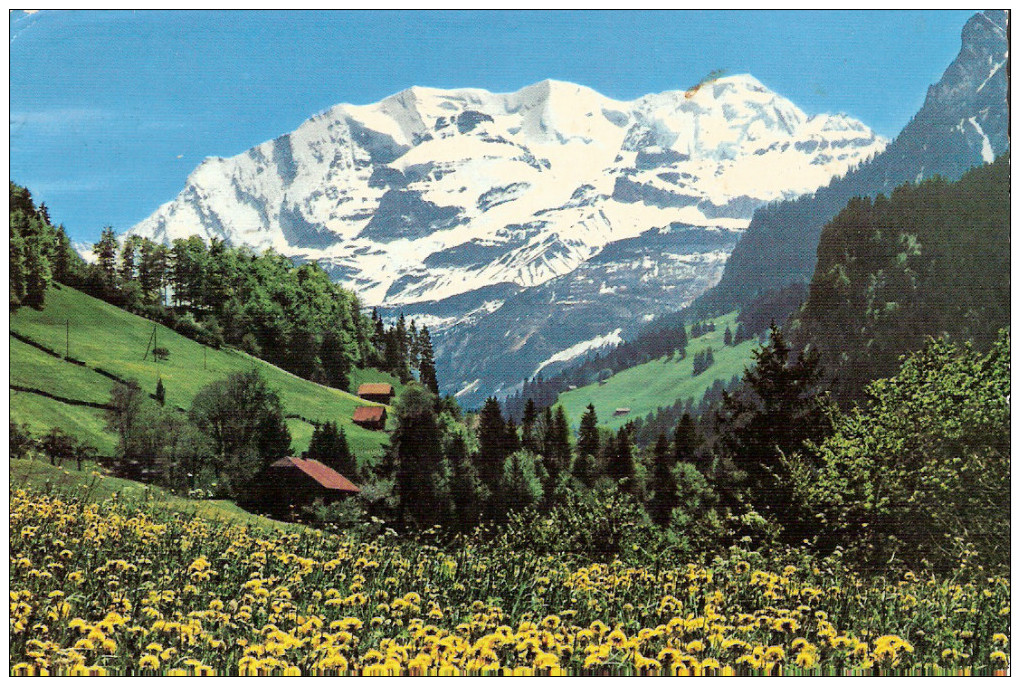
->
10;183;439;392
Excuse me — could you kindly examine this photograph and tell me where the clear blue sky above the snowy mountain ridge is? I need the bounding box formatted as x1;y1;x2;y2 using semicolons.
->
10;10;974;241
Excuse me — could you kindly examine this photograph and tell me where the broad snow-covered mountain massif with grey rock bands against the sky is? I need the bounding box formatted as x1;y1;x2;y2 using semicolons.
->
131;71;885;403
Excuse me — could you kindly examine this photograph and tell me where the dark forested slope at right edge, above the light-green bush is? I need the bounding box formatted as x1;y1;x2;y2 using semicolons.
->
794;154;1010;401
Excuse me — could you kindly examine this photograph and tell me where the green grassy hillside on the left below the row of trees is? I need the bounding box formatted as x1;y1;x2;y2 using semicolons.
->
10;285;394;461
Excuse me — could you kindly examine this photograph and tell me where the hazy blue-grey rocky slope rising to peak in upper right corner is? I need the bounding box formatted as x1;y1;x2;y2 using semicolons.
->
697;11;1009;314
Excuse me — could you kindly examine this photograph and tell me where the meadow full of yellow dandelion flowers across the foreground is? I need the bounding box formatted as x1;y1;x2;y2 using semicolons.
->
9;489;1010;675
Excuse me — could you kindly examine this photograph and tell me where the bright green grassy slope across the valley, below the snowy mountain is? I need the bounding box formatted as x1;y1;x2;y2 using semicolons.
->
557;313;758;429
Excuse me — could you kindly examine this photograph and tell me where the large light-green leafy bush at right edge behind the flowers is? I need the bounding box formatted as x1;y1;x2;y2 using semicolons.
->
791;331;1010;568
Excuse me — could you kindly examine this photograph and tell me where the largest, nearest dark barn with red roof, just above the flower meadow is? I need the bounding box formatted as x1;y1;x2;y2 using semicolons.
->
252;456;361;517
